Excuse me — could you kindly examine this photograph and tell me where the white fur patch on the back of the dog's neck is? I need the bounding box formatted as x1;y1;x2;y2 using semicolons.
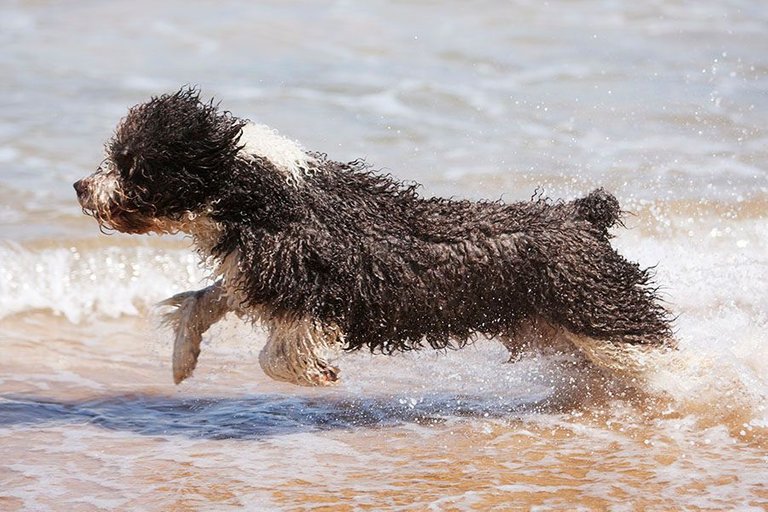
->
239;123;314;180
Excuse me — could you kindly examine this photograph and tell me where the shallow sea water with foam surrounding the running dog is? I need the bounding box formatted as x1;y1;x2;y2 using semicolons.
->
0;0;768;511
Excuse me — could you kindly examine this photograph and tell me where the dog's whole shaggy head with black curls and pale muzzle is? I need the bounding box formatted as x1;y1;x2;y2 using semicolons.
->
74;88;246;233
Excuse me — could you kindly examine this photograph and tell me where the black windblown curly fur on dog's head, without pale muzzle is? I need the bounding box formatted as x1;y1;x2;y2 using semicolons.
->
107;89;245;218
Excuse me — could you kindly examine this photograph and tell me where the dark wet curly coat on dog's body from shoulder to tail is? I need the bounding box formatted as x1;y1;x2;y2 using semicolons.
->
224;159;669;352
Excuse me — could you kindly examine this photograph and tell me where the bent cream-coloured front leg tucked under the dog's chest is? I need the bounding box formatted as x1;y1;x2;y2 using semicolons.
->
259;316;343;386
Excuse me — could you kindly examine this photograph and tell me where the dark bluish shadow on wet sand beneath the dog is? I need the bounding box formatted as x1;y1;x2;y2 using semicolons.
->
0;388;562;439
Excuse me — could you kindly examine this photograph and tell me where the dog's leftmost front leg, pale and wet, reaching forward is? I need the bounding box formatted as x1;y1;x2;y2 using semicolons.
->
158;281;230;384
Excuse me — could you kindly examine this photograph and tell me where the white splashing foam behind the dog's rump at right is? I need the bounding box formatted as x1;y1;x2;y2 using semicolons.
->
618;218;768;427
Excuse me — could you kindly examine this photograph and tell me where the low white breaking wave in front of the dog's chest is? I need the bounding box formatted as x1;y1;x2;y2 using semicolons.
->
0;242;205;323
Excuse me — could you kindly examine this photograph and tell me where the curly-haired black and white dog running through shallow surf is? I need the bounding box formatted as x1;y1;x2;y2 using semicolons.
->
74;89;674;385
